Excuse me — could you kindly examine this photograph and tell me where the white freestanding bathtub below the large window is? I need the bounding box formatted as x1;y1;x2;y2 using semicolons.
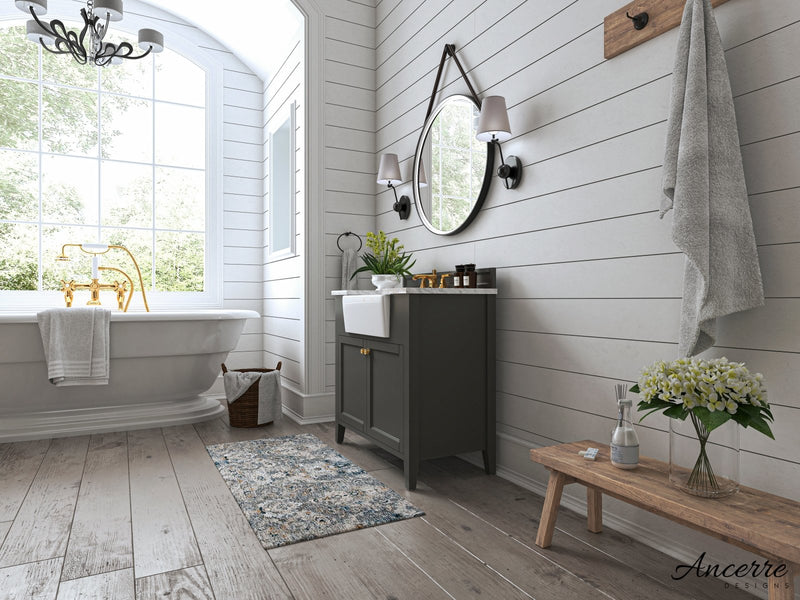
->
0;310;259;442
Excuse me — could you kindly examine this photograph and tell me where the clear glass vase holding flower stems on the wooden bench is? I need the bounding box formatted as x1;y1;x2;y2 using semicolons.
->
669;413;739;498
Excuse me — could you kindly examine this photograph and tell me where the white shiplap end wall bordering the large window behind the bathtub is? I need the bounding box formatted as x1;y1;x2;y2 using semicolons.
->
0;0;264;368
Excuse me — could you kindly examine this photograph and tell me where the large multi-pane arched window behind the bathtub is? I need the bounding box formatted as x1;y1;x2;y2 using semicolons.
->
0;21;216;308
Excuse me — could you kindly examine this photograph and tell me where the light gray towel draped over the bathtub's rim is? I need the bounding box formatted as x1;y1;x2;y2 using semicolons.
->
36;307;111;386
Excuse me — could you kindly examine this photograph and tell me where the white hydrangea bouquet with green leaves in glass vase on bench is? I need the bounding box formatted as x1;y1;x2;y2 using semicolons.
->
631;357;775;498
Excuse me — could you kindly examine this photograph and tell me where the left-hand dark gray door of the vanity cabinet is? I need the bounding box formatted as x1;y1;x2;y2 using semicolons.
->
336;336;369;432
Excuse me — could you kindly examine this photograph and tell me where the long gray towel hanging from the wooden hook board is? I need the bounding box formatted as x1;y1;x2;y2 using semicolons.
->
661;0;764;356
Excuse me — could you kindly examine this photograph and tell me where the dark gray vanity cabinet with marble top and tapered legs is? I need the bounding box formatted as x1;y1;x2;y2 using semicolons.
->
333;288;497;490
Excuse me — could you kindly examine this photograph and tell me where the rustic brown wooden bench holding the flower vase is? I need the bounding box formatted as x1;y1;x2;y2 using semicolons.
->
531;440;800;600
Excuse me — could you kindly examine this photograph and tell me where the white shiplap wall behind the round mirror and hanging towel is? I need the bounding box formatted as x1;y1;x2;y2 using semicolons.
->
372;0;800;580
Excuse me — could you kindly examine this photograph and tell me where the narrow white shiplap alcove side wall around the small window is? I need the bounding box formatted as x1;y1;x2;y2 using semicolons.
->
263;37;306;392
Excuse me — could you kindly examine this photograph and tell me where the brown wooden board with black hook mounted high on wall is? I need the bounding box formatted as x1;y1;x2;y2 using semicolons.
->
603;0;728;58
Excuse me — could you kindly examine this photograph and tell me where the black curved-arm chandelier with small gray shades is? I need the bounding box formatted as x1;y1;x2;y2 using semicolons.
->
15;0;164;67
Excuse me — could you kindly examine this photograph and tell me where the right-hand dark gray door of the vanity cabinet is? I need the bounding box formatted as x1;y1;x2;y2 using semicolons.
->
364;339;405;451
